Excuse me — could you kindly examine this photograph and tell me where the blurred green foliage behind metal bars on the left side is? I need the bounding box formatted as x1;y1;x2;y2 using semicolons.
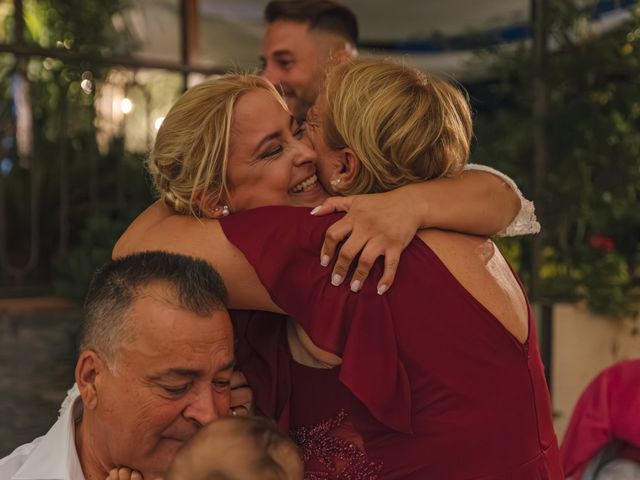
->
0;0;151;299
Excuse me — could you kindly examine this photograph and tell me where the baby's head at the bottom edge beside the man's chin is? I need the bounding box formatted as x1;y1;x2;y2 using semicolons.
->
166;417;304;480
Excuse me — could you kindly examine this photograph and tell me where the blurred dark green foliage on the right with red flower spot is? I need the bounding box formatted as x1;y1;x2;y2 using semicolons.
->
473;0;640;316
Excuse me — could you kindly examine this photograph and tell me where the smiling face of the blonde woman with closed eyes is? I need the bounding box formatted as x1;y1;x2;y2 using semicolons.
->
227;88;327;211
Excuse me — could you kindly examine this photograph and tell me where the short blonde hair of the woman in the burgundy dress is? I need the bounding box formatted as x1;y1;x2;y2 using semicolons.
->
322;59;472;195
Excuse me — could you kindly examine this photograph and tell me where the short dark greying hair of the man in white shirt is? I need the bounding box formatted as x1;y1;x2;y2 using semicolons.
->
80;252;228;363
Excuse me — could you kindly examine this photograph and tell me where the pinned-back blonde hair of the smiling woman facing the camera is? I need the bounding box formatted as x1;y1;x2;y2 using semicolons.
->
147;74;288;217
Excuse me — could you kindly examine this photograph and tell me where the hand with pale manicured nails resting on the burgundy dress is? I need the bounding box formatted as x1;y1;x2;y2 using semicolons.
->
312;188;421;295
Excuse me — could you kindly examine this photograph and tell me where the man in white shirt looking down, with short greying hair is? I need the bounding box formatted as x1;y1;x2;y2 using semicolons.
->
0;252;234;480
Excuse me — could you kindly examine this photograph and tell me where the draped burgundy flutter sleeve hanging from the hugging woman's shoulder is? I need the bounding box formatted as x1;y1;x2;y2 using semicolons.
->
220;206;413;433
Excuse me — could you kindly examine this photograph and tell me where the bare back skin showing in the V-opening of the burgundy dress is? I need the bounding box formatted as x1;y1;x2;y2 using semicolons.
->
419;229;529;343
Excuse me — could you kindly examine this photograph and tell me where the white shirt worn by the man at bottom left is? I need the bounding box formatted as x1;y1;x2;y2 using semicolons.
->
0;386;85;480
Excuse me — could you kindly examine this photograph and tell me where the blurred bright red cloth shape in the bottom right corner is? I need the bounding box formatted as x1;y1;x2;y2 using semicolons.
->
561;360;640;480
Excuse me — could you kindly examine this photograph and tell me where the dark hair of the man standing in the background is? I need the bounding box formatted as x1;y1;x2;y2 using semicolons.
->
264;0;358;47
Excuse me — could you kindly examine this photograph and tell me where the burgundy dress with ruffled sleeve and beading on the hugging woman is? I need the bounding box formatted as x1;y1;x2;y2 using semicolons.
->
221;207;564;480
